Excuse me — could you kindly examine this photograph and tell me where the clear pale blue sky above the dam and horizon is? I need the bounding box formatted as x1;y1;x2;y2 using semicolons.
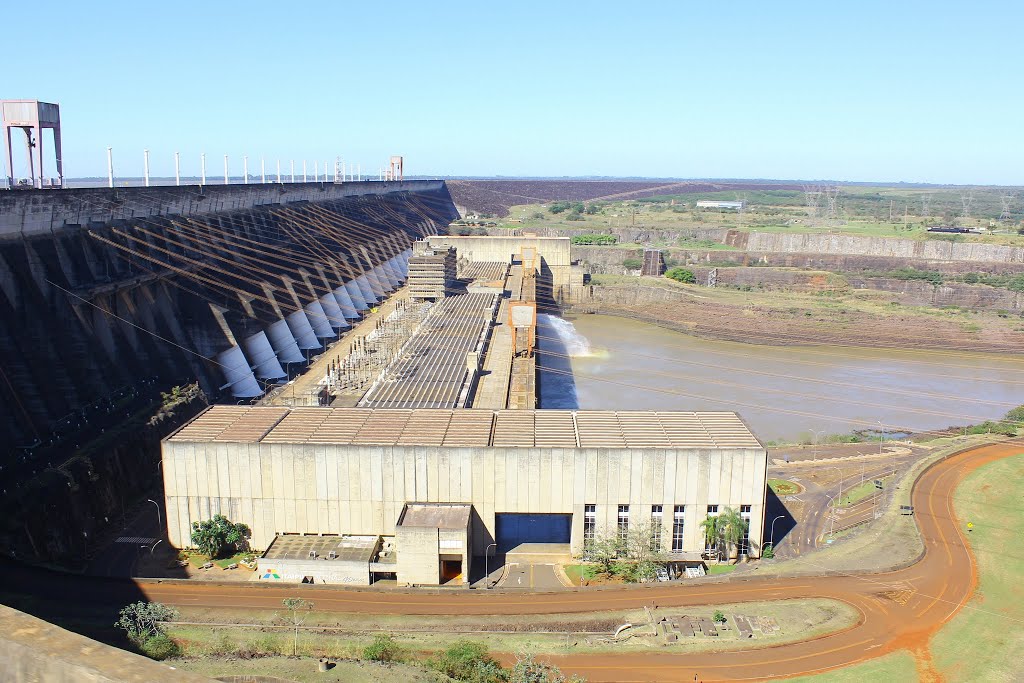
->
0;0;1024;184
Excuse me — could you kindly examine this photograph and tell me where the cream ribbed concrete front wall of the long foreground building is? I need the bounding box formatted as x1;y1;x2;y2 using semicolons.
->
163;409;767;565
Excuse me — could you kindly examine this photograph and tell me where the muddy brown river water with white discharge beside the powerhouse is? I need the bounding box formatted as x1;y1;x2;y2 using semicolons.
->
538;315;1024;440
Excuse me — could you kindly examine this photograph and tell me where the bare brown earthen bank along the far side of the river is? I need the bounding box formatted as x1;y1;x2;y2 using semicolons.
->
568;275;1024;354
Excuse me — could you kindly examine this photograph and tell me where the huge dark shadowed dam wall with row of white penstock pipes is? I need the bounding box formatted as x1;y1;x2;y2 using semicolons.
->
0;181;458;558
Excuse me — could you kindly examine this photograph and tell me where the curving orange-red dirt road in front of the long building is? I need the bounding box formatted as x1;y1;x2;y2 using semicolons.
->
130;442;1024;683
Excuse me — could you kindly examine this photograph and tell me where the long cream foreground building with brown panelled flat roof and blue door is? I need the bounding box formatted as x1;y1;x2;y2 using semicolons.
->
163;405;767;585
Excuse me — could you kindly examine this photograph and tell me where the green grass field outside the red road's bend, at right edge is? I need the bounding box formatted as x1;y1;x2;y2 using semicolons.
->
932;446;1024;683
